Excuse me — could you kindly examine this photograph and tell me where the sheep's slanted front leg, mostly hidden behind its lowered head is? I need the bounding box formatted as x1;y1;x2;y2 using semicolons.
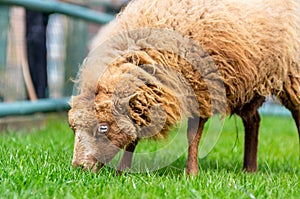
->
117;140;138;175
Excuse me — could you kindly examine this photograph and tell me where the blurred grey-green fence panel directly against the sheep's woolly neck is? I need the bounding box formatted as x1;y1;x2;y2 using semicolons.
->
64;19;88;96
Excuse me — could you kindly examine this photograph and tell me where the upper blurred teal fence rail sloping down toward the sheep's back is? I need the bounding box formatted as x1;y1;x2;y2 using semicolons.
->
0;0;114;24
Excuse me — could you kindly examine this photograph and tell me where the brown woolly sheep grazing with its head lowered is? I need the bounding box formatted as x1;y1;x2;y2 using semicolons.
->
69;0;300;174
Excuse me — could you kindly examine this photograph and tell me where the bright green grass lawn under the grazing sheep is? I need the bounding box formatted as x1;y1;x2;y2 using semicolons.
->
0;113;300;198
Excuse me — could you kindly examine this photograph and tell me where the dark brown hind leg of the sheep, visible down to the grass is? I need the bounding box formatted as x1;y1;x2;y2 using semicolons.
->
238;97;265;172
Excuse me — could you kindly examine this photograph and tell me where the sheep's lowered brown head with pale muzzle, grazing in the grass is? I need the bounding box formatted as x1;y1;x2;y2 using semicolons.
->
69;76;136;172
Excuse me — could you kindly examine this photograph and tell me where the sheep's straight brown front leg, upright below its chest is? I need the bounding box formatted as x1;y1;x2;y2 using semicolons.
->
186;118;207;175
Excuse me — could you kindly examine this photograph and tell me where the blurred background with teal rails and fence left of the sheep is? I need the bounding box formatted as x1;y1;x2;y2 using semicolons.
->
0;0;128;128
